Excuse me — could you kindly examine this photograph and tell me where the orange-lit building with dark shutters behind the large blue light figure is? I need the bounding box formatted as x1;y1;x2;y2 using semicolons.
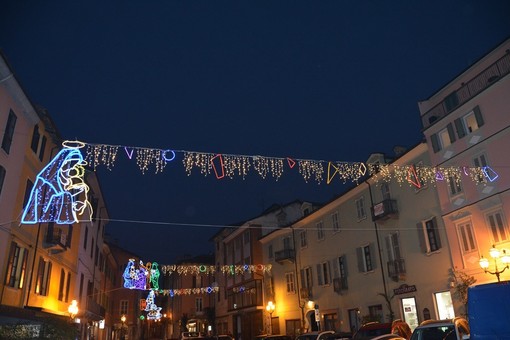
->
0;51;112;339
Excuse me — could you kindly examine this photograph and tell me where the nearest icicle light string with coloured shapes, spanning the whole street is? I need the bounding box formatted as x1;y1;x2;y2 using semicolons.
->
80;142;498;188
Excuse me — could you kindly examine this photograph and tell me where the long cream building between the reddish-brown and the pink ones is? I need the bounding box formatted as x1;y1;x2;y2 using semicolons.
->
261;143;459;335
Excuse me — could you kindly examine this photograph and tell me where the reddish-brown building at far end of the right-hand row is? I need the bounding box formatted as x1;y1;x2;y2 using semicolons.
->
212;201;316;339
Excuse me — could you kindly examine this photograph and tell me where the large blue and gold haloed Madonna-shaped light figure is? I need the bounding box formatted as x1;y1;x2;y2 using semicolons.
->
21;141;93;224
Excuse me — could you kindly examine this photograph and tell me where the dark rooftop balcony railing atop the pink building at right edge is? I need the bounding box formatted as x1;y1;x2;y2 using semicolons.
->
422;53;510;128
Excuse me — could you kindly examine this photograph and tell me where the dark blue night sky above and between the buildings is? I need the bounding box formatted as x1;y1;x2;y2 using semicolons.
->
0;0;510;263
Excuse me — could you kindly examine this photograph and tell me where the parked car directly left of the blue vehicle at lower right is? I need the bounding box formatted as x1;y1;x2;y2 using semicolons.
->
411;317;470;340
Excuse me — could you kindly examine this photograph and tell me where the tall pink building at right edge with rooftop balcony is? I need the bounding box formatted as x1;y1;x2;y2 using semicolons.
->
419;39;510;284
